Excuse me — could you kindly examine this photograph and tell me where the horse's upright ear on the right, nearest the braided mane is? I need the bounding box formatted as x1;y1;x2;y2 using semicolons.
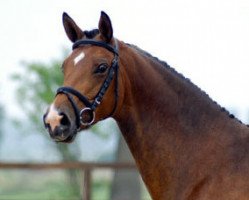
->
99;11;113;43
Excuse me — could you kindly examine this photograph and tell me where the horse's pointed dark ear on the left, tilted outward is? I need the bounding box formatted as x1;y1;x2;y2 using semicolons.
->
62;12;84;43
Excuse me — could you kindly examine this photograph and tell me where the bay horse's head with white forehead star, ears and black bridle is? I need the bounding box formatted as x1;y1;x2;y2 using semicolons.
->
44;12;118;142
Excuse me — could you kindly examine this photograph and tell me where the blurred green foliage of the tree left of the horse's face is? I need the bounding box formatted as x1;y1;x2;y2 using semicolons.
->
12;60;63;129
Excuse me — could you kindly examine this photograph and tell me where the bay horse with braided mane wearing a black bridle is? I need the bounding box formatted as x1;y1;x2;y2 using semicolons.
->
44;12;249;200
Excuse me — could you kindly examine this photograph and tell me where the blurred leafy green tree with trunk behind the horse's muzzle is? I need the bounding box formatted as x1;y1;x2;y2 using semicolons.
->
12;54;80;196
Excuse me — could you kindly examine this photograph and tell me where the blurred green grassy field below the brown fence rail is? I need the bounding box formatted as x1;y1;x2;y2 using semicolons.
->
0;170;150;200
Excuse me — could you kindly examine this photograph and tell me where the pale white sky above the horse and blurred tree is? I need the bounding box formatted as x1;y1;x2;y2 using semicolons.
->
0;0;249;121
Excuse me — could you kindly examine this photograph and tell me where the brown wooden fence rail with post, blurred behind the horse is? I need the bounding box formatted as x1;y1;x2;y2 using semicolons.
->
0;162;136;200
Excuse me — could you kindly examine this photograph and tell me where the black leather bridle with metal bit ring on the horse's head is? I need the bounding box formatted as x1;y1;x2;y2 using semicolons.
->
56;39;119;129
